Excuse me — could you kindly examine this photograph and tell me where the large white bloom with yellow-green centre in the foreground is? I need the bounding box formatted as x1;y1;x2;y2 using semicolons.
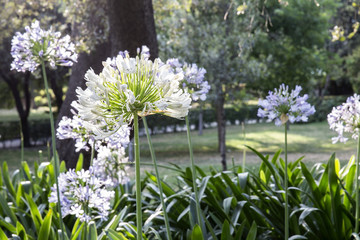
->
72;47;191;138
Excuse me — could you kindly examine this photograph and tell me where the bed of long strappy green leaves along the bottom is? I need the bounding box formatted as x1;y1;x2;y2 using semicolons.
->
0;145;355;239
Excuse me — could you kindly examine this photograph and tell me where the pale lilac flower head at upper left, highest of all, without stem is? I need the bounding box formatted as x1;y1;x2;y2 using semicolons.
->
11;21;77;72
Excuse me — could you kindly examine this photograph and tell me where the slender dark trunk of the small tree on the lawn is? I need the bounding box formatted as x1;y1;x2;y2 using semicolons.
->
215;86;227;171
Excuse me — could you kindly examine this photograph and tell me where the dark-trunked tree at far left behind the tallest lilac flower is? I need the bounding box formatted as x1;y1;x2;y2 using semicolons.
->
0;0;71;147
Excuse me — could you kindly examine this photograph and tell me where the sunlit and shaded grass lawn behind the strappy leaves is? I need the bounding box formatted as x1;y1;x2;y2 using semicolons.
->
0;122;356;174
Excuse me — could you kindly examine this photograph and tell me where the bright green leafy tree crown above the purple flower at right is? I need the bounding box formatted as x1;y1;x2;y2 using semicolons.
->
252;0;336;93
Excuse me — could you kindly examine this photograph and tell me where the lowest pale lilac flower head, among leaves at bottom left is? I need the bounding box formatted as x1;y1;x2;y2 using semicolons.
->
49;167;115;222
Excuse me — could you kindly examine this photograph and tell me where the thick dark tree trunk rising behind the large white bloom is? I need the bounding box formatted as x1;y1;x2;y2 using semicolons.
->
57;0;158;168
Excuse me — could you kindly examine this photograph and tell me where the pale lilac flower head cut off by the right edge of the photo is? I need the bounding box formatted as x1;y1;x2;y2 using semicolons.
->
327;94;360;143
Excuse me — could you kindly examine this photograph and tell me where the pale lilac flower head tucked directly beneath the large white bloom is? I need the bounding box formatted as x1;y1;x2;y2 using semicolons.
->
56;115;130;152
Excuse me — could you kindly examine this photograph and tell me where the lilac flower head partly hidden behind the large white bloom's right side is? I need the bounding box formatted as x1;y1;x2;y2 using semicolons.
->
166;58;210;101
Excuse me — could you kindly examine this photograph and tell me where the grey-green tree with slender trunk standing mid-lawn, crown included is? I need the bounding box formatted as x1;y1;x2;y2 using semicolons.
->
155;0;265;169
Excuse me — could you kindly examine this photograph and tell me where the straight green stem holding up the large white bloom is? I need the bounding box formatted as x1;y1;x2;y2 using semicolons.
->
134;112;142;240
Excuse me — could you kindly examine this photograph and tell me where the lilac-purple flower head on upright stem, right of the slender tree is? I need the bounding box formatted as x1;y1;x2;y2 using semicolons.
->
257;84;315;126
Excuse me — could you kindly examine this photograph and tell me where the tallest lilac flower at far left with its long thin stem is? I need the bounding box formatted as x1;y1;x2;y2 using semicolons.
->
11;21;77;238
